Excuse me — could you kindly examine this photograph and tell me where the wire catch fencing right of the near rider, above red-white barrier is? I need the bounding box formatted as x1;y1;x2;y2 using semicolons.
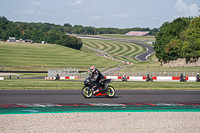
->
104;66;200;77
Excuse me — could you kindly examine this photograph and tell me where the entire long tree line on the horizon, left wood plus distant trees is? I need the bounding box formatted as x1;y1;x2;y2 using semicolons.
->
0;16;159;49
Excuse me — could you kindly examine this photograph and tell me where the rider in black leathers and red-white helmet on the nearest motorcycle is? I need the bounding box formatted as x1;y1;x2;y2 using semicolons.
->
90;66;105;94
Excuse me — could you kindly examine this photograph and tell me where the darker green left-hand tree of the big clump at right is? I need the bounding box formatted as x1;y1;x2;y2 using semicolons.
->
154;18;191;61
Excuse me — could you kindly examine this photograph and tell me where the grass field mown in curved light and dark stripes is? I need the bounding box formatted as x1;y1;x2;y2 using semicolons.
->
82;39;146;63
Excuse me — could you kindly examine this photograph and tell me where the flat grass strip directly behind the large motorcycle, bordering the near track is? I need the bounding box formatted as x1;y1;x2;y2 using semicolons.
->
0;79;200;90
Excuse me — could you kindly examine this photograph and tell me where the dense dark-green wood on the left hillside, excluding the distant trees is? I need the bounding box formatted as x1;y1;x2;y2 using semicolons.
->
0;16;82;50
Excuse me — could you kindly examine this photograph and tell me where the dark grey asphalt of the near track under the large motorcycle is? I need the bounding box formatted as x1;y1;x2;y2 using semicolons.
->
0;90;200;104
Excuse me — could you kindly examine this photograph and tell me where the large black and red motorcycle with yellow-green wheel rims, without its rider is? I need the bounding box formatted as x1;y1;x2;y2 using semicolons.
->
81;77;115;98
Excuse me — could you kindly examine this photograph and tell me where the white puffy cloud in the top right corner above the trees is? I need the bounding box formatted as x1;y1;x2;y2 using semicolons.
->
175;0;199;16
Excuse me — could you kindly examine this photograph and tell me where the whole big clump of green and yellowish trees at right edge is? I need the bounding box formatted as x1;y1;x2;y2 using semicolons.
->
154;17;200;62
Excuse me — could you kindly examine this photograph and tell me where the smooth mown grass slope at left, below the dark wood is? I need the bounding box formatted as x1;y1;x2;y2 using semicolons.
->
0;43;117;71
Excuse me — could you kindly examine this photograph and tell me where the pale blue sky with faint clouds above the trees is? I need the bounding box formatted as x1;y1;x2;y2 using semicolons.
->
0;0;200;29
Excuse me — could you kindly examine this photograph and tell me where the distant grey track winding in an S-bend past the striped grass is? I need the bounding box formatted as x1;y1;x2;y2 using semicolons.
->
80;36;155;61
